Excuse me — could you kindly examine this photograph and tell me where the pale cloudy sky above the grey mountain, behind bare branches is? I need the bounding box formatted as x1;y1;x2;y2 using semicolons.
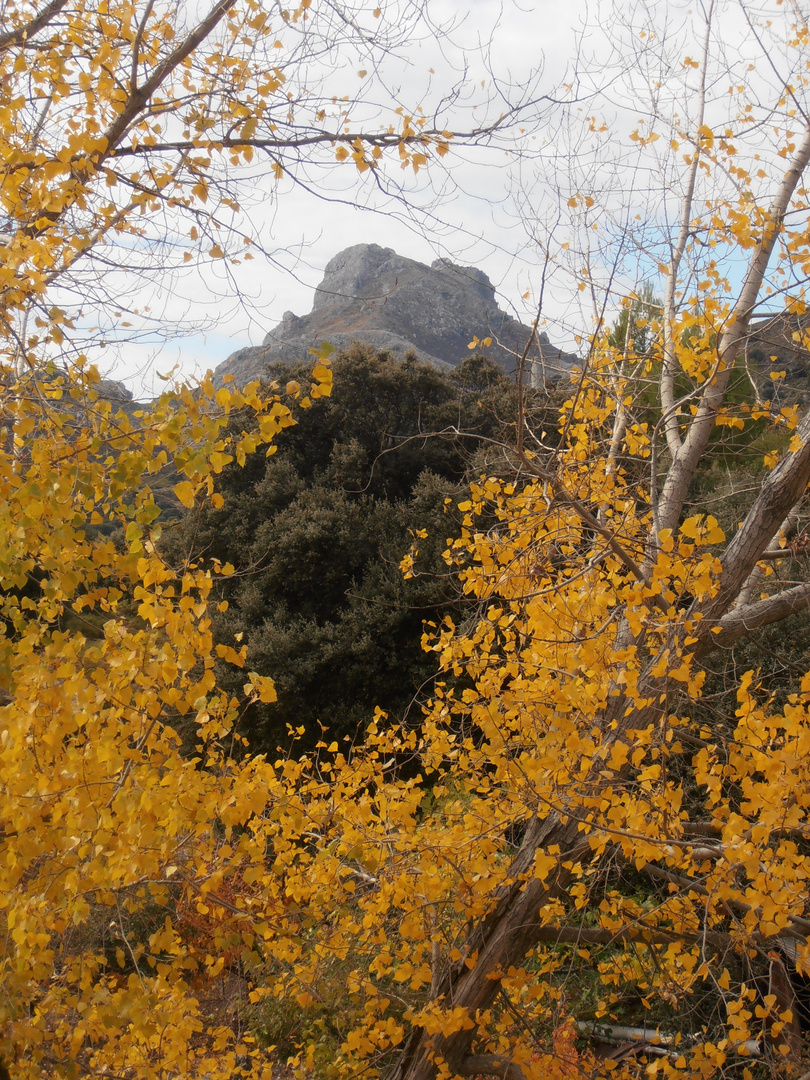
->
81;0;801;400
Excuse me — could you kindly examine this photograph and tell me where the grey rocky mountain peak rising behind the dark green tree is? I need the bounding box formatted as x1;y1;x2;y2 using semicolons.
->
214;244;578;384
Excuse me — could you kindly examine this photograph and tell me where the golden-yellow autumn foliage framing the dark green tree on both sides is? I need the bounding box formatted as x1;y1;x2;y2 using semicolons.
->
7;0;810;1080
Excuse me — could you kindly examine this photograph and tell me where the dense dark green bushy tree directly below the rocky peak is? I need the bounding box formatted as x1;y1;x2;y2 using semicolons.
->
160;347;556;750
